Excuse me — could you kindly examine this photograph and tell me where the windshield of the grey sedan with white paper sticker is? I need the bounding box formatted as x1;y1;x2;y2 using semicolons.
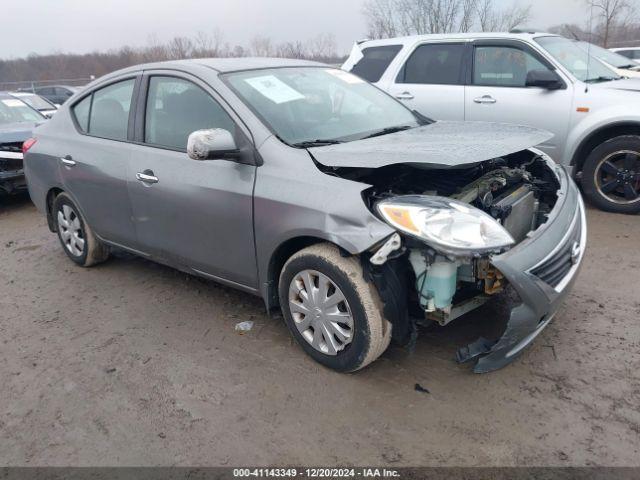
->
224;67;421;146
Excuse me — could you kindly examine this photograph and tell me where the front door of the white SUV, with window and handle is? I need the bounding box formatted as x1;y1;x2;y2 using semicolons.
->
465;40;573;160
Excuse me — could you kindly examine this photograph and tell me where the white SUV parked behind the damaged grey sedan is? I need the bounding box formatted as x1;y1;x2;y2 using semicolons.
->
343;33;640;213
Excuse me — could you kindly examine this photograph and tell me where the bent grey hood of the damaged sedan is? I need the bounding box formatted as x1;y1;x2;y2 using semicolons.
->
309;121;553;168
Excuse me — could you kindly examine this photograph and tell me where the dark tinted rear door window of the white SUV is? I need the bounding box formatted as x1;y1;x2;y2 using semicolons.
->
397;44;465;85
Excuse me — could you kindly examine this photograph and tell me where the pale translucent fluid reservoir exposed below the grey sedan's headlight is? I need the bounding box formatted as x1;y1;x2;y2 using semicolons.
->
409;250;458;311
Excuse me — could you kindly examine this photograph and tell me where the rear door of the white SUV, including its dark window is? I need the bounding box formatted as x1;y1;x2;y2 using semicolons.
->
388;42;467;120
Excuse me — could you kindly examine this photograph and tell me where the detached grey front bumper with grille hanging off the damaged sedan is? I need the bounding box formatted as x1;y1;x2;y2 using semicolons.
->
458;163;587;373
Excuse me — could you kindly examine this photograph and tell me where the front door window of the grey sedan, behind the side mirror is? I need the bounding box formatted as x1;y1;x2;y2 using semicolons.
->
144;76;235;150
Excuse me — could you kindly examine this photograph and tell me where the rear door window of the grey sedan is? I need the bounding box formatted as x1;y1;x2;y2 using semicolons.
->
88;78;135;140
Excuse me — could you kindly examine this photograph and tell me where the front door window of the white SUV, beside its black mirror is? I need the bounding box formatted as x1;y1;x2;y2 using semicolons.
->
473;47;547;87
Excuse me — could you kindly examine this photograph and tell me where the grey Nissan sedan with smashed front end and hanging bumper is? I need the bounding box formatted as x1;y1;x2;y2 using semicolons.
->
25;58;586;372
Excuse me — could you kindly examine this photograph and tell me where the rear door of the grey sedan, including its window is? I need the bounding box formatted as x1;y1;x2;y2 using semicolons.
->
62;74;139;248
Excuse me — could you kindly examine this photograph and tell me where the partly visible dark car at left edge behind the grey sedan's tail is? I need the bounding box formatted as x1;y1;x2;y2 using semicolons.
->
0;92;46;195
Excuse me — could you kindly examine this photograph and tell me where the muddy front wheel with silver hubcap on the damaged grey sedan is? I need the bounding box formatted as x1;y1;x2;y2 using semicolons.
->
278;243;391;372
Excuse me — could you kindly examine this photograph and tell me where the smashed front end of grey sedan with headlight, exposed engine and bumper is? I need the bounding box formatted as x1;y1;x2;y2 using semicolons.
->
320;149;586;373
